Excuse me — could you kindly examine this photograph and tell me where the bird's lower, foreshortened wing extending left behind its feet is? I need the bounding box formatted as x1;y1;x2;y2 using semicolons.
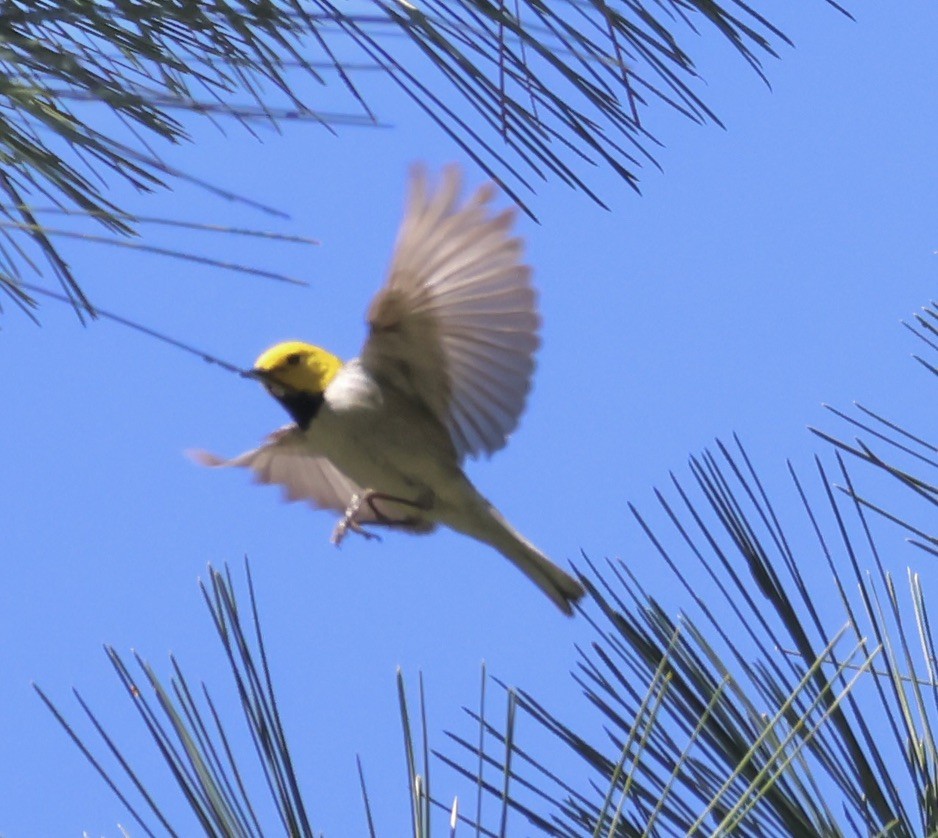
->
189;425;374;523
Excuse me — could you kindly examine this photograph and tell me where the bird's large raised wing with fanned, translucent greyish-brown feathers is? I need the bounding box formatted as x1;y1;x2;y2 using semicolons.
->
361;166;540;457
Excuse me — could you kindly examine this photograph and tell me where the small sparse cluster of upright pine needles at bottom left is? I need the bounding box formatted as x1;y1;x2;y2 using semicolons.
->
36;562;315;838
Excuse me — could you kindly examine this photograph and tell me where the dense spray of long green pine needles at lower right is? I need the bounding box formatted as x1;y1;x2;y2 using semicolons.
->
441;304;938;836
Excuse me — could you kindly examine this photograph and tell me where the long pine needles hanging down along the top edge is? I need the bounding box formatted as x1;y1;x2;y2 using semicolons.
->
0;0;843;315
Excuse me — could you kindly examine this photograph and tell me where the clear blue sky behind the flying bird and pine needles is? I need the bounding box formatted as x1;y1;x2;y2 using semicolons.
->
0;1;938;837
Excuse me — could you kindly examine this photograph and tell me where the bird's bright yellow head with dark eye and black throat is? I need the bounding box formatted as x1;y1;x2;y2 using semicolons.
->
251;340;342;428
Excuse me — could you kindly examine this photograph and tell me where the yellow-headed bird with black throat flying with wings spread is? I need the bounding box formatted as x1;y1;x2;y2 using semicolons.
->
190;164;584;615
